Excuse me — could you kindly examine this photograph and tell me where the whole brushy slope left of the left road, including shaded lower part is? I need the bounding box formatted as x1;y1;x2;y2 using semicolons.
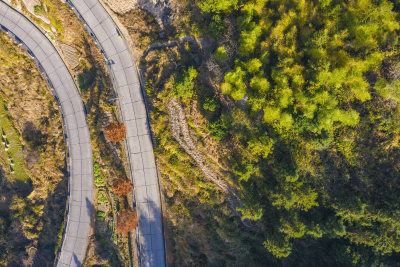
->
0;32;67;266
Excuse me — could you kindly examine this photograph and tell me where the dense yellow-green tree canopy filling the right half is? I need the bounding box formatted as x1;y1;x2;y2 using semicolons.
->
199;0;400;264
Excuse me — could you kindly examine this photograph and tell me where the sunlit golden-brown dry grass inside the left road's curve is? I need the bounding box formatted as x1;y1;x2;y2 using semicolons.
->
0;33;65;203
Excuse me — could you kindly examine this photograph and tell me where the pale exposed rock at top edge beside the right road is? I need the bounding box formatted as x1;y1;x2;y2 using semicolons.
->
104;0;170;27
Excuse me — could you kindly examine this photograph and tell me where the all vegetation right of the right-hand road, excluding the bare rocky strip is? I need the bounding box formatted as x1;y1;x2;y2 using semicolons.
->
134;0;400;266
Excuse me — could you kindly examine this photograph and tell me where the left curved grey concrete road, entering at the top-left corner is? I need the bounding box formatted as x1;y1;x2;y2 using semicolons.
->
0;1;93;266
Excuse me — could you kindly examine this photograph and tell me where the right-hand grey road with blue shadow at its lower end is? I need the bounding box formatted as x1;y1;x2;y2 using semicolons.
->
67;0;165;267
